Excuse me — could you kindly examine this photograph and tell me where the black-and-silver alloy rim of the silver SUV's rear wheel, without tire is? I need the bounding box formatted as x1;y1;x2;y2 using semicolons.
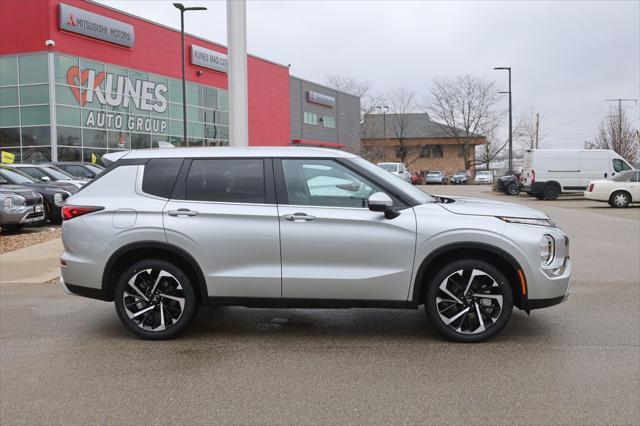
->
122;269;185;331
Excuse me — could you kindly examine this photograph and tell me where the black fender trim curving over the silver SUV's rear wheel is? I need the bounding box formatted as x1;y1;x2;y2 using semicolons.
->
102;241;208;301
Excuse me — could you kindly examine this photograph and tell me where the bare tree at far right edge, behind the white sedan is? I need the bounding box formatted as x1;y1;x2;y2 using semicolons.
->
585;108;640;163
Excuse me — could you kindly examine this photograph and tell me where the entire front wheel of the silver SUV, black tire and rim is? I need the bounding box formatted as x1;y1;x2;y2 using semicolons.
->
424;259;513;343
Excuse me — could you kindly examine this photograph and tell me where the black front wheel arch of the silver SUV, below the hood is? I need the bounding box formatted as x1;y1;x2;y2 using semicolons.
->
412;242;527;309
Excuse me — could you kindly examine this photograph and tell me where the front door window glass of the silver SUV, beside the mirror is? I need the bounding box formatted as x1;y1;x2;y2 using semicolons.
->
282;159;381;208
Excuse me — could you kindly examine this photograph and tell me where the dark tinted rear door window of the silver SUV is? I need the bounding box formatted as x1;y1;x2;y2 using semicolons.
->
185;159;266;204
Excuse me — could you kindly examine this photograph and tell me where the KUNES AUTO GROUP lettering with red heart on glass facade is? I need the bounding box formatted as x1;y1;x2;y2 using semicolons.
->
67;65;168;133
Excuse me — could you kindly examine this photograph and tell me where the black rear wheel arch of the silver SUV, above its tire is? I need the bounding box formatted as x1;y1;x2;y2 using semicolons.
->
102;241;208;304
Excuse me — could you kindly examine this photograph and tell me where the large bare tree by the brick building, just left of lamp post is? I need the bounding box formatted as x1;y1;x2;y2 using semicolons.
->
428;74;499;169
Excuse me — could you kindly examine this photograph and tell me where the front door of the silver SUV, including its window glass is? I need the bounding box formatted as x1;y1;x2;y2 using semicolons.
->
274;158;416;301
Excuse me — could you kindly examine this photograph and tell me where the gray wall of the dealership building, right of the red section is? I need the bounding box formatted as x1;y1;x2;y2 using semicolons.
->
289;76;360;151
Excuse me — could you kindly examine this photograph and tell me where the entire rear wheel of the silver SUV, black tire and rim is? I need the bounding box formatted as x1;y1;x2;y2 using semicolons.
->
114;259;196;340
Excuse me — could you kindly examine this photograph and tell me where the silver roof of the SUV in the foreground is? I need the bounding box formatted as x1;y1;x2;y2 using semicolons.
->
116;146;355;159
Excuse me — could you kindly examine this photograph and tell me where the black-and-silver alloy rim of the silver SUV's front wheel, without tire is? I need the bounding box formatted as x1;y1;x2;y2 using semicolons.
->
436;269;503;334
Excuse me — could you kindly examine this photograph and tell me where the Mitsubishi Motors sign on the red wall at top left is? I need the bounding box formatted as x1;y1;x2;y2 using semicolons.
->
60;3;135;47
